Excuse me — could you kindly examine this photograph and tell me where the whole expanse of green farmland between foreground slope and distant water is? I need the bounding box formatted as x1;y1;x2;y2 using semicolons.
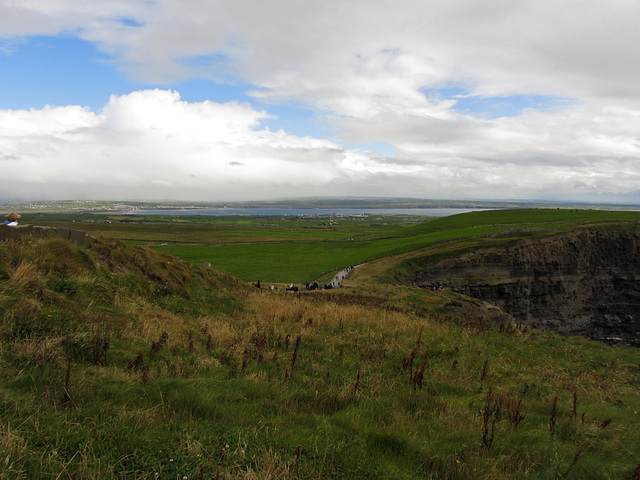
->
17;209;640;283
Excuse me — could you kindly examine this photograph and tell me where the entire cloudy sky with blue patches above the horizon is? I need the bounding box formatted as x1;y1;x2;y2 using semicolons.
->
0;0;640;203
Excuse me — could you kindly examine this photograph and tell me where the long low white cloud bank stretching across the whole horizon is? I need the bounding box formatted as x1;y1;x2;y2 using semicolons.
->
0;89;640;201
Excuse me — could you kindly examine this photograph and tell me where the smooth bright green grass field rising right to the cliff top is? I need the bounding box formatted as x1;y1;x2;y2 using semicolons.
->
152;210;640;283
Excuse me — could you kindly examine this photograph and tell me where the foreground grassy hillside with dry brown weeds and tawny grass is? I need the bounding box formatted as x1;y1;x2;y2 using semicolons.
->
0;233;640;479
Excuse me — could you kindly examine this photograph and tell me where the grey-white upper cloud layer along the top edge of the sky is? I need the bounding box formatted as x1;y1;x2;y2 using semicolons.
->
5;0;640;100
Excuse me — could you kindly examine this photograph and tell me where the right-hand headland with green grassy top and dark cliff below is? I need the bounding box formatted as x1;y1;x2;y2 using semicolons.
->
349;210;640;346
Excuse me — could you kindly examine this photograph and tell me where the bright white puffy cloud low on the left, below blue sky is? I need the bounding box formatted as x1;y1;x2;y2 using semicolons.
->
0;90;348;200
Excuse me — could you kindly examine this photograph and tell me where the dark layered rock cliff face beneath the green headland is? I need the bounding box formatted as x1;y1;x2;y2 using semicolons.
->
413;230;640;346
